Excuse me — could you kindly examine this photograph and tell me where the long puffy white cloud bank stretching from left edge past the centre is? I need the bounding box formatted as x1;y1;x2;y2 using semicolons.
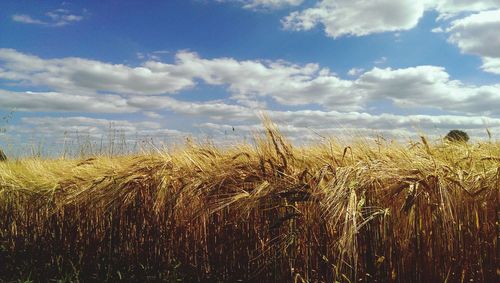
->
0;49;361;110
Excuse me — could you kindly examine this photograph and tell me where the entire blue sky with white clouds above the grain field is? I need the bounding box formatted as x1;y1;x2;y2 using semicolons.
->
0;0;500;155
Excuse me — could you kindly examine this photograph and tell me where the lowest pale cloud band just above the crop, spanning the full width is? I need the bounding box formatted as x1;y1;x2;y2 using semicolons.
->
8;110;500;152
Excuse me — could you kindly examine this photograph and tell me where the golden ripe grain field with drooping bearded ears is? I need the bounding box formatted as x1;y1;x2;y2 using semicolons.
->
0;123;500;282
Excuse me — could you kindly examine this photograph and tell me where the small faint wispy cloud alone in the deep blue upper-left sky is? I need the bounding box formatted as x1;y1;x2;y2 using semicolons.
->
12;9;85;27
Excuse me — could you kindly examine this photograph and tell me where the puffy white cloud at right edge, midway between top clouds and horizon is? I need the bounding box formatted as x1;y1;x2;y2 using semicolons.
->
356;66;500;115
